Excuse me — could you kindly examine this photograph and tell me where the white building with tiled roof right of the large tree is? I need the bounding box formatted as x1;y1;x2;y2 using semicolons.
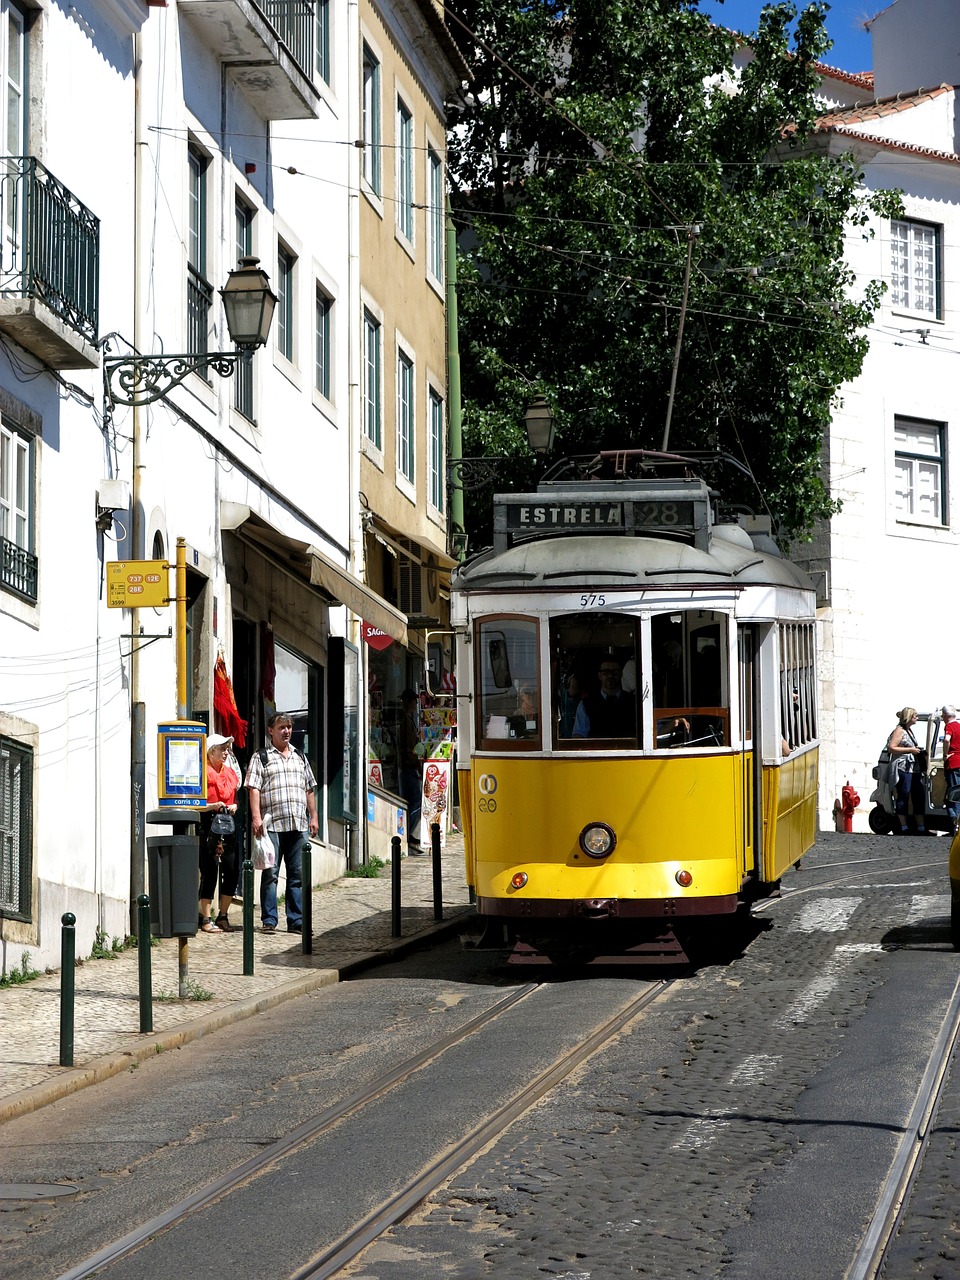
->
794;0;960;829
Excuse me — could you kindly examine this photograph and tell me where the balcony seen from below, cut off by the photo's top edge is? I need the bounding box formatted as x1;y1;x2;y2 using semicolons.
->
179;0;321;120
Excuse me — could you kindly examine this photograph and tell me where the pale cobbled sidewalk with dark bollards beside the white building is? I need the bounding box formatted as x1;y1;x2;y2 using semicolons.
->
0;835;472;1124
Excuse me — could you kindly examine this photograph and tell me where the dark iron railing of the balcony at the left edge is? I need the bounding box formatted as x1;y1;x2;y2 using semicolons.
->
0;156;100;342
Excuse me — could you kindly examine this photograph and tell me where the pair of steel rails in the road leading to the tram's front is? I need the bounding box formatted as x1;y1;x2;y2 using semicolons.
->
50;979;672;1280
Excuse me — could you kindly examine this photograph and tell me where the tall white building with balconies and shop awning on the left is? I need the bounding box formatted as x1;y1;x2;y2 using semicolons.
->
0;0;460;973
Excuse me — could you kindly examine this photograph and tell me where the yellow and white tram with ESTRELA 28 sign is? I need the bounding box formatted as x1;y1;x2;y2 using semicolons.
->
451;454;818;960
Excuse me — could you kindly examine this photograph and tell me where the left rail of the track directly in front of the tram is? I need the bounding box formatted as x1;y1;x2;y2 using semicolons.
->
58;982;540;1280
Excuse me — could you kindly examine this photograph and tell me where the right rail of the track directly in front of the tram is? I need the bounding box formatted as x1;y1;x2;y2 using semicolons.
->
289;979;672;1280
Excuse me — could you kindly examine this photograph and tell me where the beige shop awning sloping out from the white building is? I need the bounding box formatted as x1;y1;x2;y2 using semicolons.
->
220;503;407;645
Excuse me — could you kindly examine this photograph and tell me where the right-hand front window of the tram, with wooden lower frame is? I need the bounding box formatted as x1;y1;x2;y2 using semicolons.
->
650;609;730;750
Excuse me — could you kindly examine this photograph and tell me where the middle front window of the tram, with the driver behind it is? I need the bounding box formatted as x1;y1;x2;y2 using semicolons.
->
550;613;641;750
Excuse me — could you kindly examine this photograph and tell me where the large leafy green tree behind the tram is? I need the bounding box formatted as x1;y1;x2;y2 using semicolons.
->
447;0;896;536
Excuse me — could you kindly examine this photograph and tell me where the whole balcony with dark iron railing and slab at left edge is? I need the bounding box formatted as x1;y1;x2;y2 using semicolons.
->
0;156;100;369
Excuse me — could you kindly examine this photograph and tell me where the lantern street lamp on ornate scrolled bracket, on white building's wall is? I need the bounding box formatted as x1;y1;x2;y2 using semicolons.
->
104;257;276;406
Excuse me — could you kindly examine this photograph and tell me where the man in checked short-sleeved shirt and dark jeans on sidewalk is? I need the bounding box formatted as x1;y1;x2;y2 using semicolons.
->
247;712;320;933
